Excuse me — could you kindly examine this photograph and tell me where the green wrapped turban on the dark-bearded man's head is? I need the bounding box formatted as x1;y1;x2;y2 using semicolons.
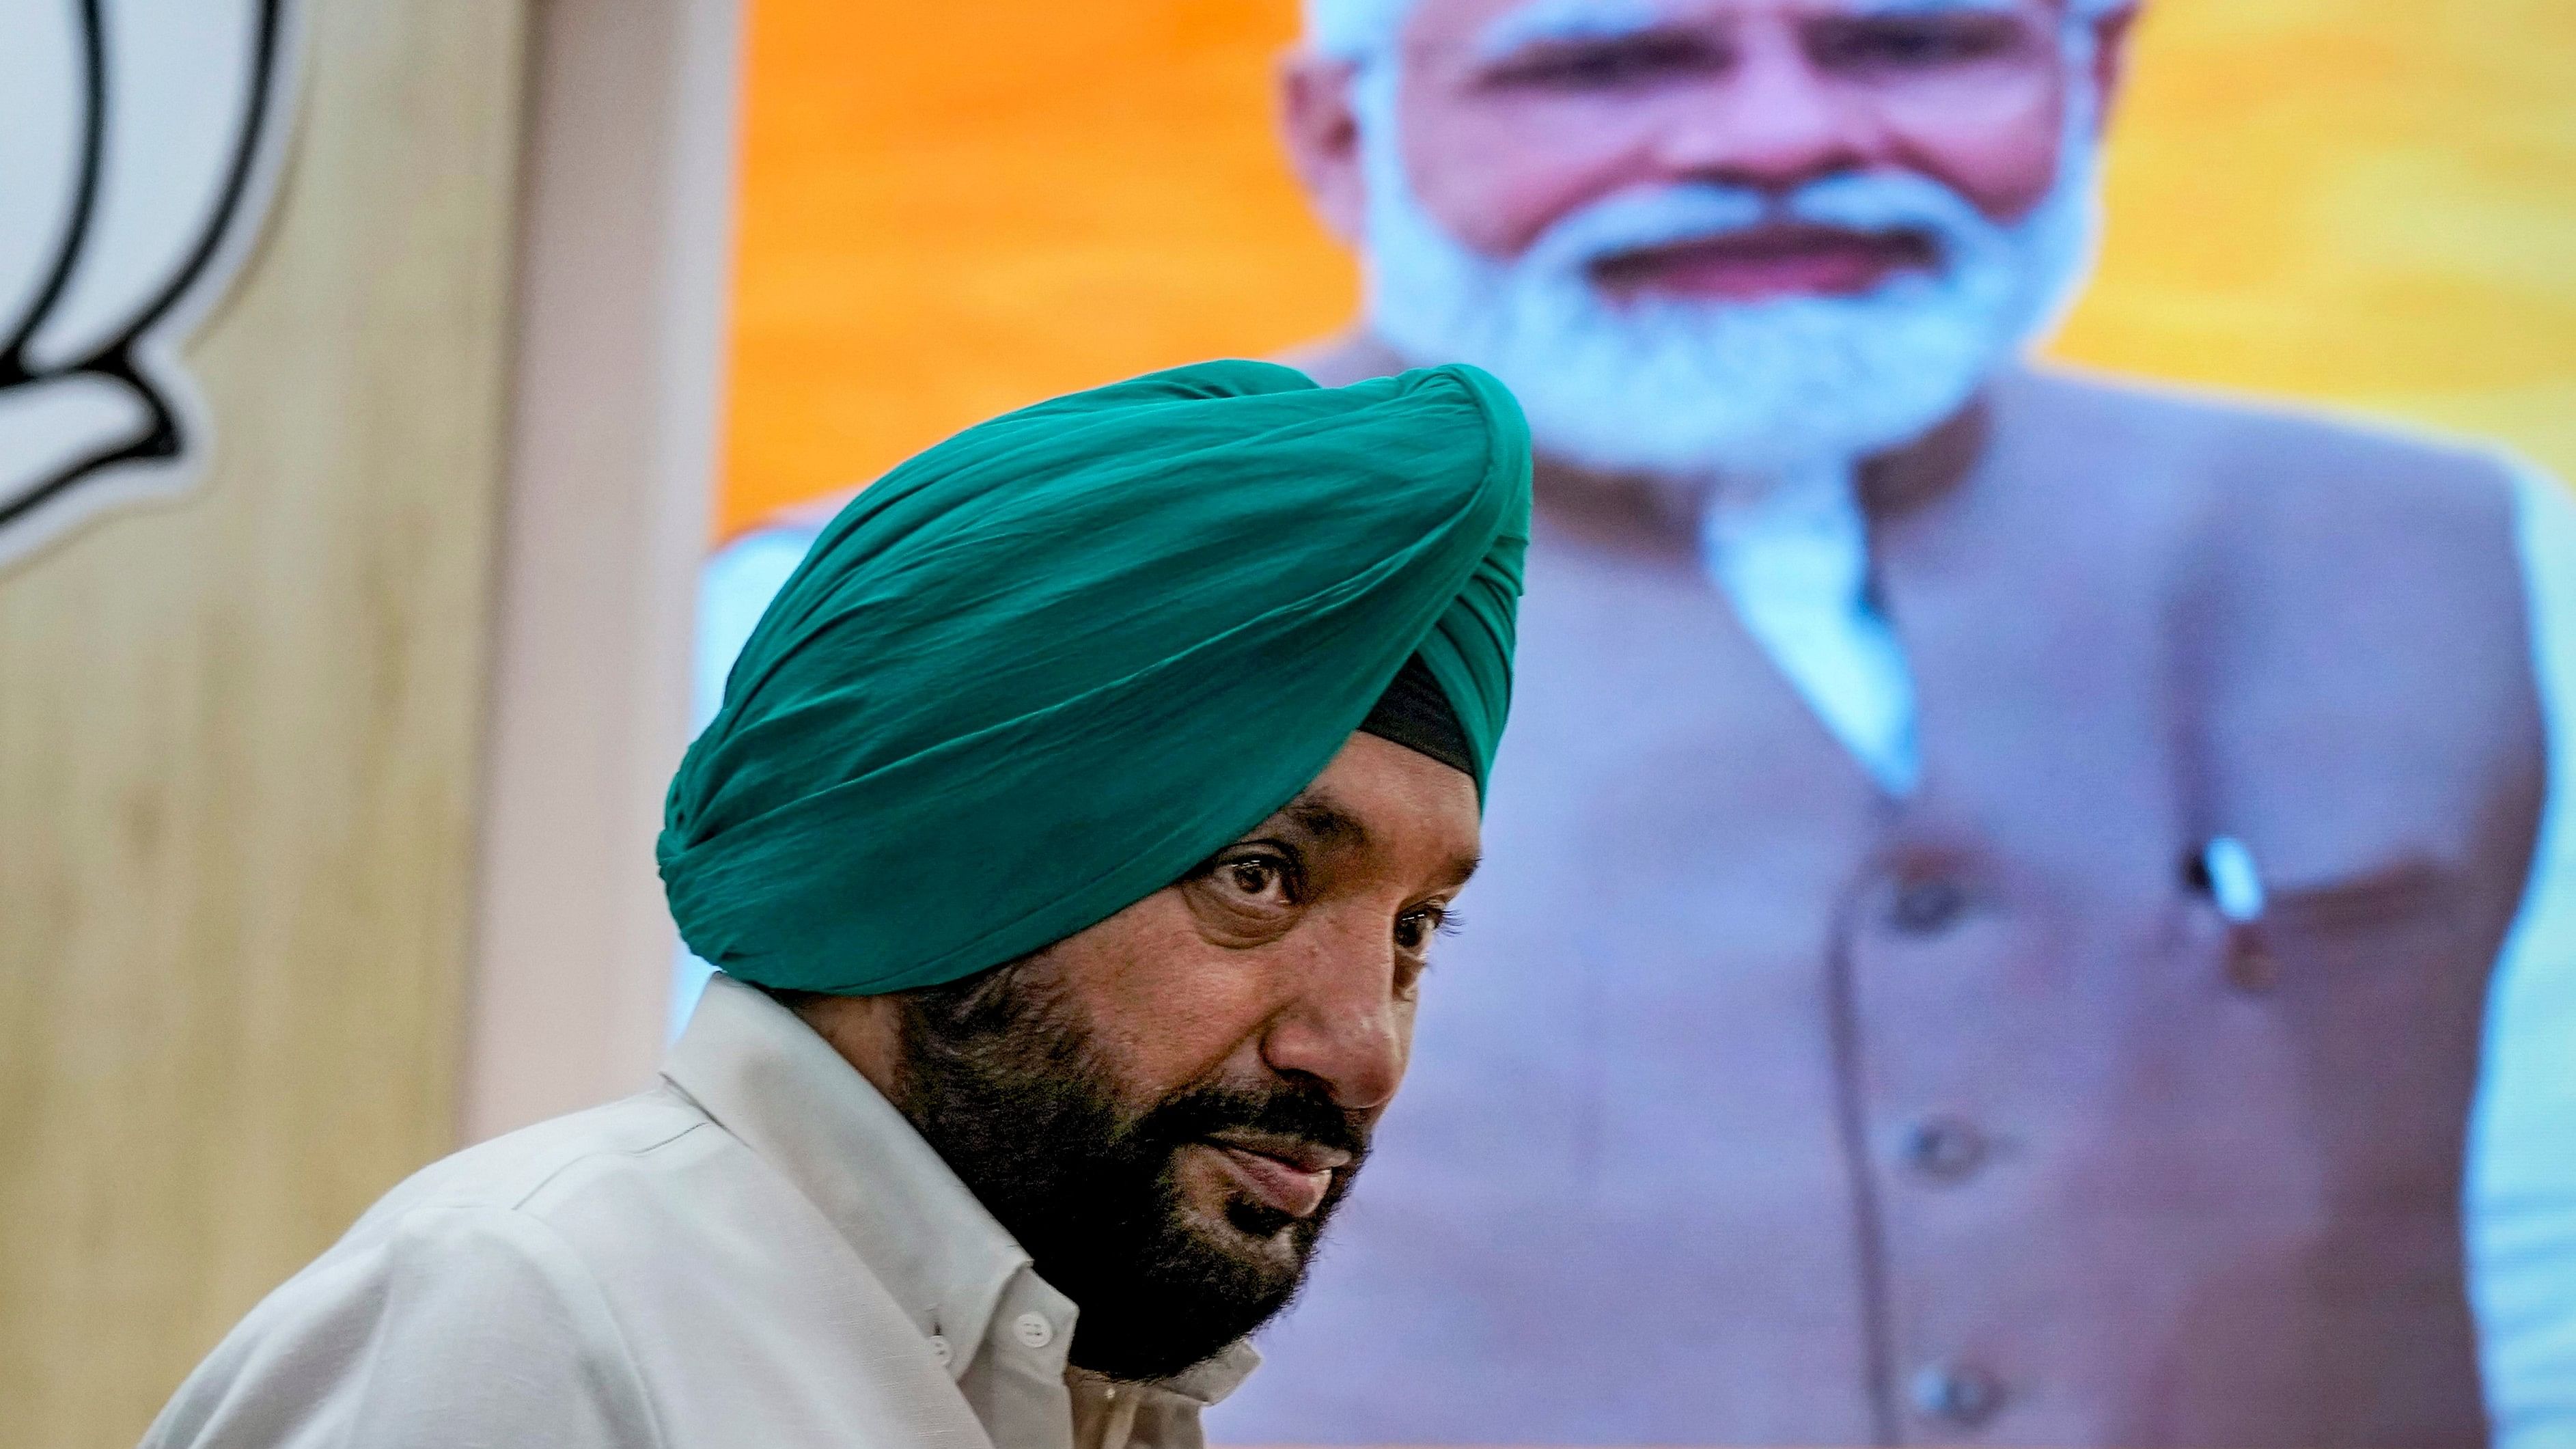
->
659;361;1530;995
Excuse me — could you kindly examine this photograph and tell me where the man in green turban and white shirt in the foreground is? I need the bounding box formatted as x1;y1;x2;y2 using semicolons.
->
147;361;1530;1449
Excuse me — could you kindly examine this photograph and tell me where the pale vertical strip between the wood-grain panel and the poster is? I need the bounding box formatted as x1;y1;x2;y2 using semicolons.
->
464;0;742;1140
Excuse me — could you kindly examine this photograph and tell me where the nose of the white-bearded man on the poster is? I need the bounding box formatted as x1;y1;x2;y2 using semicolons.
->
1657;20;1875;193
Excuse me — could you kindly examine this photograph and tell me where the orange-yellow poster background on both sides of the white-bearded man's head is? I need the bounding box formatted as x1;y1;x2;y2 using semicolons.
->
716;0;2576;536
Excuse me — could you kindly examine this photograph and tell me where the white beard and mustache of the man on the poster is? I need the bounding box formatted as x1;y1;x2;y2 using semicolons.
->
1353;59;2099;477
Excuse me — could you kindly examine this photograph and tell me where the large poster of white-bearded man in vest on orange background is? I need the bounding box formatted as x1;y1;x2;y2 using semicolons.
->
682;0;2576;1449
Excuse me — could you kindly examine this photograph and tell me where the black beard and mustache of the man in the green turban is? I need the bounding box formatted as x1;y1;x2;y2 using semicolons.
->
896;962;1368;1382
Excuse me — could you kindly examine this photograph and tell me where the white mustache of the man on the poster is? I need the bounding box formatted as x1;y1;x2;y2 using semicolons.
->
1520;173;2004;281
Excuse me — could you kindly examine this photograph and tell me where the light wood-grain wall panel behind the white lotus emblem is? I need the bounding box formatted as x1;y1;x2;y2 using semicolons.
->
0;0;523;1446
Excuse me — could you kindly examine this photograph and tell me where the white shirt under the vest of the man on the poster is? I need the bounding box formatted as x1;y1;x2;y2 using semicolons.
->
675;469;2576;1449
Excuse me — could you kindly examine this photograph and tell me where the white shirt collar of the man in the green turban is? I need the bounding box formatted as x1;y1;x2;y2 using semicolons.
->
662;972;1260;1405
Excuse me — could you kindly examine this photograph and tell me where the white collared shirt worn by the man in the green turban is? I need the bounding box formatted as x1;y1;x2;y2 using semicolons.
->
144;980;1257;1449
